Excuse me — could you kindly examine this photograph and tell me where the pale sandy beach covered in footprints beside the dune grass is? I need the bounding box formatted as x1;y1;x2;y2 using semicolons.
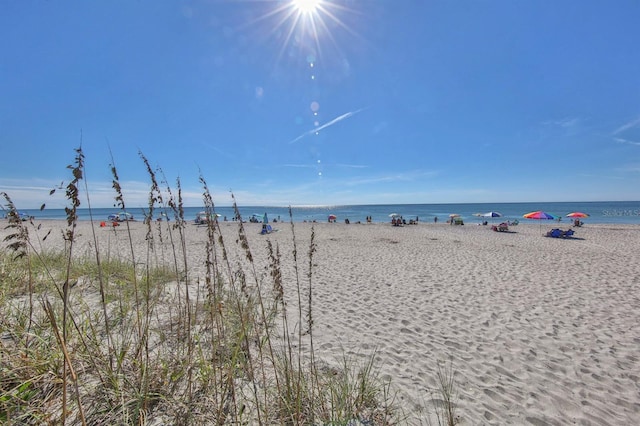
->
0;221;640;425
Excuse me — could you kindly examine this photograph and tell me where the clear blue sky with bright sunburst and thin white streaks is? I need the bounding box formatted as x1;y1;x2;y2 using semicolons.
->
0;0;640;208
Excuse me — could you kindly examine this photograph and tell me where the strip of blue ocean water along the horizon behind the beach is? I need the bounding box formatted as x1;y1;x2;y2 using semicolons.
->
6;201;640;224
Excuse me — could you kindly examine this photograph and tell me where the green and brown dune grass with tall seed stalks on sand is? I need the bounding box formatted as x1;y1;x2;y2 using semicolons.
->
0;149;416;425
